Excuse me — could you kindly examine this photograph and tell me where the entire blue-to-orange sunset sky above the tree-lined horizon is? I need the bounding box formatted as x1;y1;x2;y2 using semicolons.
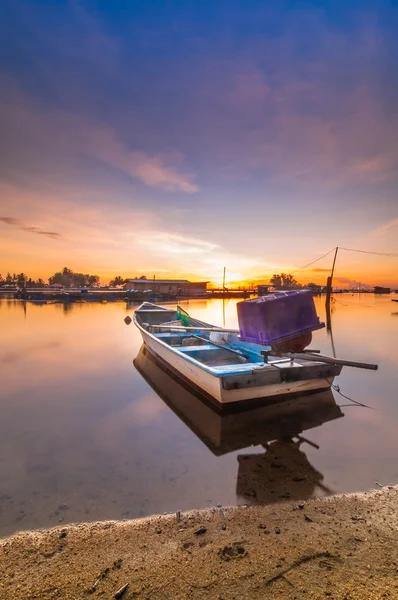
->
0;0;398;287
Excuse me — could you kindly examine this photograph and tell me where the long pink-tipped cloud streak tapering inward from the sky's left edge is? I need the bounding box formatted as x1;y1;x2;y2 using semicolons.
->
0;75;199;194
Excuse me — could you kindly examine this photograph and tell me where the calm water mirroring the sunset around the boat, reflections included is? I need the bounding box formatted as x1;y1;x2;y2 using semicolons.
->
0;294;398;535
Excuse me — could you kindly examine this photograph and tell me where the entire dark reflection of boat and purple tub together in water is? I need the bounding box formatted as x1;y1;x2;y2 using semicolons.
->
134;345;344;504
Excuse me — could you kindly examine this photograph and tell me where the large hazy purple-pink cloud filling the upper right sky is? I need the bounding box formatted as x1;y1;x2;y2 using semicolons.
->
171;9;398;195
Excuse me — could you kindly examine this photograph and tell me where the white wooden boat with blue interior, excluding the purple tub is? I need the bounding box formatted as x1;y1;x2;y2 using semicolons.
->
133;302;377;410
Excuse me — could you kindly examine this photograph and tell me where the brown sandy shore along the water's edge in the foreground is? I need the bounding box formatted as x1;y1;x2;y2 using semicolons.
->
0;487;398;600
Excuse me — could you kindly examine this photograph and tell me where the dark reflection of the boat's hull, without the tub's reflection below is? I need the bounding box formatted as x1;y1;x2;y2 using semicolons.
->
134;344;344;456
